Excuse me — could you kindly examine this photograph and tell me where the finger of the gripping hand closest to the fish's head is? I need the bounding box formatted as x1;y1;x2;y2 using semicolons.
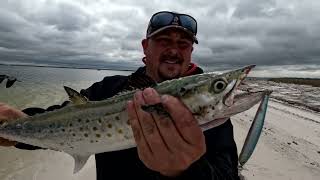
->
161;95;204;145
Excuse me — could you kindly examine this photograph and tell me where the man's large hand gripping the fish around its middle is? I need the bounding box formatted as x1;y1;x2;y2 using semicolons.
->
127;88;206;176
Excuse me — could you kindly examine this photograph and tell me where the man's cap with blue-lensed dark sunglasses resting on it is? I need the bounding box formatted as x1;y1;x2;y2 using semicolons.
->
147;11;197;41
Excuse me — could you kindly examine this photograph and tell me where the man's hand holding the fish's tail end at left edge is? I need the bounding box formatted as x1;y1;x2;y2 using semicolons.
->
0;102;26;146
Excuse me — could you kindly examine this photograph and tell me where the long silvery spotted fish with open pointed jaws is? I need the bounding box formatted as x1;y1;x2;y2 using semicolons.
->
0;65;269;173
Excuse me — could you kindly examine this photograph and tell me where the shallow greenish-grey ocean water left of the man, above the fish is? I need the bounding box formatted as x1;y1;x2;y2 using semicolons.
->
0;65;132;109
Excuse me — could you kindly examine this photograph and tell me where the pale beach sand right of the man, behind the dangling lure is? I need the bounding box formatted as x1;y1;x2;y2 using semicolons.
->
233;101;320;180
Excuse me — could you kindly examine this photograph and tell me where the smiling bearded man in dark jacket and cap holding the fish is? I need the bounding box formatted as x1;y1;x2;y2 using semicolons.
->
0;11;239;180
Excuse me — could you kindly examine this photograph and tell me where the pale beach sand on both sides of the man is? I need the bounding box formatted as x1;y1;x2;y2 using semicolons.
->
0;100;320;180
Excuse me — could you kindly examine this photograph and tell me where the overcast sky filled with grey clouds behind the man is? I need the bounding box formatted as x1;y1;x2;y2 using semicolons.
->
0;0;320;77
